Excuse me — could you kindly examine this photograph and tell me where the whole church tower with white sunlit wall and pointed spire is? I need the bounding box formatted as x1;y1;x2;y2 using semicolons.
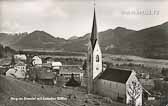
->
87;8;102;93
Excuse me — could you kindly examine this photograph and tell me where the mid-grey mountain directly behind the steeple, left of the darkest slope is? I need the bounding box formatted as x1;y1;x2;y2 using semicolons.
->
64;27;134;52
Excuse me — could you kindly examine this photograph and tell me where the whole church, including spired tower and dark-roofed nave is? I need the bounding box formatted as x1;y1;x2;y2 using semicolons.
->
87;8;142;106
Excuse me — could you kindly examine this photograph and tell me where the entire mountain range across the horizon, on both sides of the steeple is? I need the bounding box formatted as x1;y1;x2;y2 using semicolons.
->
0;22;168;59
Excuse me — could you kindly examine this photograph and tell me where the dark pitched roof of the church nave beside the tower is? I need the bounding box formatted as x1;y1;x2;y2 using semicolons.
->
98;68;132;83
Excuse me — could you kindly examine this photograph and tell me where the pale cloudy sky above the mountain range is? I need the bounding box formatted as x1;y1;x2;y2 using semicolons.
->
0;0;168;38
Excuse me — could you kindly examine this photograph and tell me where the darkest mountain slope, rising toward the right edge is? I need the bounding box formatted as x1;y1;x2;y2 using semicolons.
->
115;23;168;58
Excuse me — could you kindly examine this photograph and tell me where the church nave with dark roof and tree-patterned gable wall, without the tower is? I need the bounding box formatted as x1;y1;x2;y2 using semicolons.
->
94;68;142;106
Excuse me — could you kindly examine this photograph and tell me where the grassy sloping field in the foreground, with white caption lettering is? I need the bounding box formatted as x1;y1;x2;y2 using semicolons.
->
0;76;125;106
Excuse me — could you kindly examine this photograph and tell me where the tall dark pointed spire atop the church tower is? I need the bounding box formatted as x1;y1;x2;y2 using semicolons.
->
90;8;97;49
